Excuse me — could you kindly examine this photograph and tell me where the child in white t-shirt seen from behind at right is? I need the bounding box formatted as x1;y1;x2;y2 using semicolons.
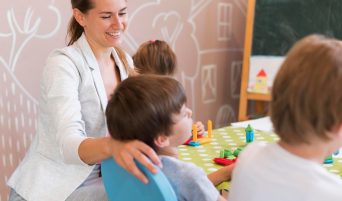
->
229;35;342;201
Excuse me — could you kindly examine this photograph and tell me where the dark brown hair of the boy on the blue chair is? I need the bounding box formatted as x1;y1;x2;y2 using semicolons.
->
106;75;186;150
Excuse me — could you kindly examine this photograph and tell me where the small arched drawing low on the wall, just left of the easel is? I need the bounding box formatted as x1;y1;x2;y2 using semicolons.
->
215;105;235;128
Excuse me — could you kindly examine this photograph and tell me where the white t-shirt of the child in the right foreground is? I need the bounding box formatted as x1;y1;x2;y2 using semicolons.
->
229;142;342;201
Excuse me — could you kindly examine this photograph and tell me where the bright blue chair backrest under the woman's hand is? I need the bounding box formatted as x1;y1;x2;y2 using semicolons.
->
101;158;177;201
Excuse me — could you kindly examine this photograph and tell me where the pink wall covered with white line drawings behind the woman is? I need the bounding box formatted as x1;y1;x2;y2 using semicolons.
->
0;0;247;201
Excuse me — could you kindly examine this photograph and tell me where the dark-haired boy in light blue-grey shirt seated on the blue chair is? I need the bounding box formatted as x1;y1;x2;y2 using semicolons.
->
106;75;232;201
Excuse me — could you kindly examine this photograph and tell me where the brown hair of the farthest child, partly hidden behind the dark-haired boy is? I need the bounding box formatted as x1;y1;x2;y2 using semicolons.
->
133;40;177;75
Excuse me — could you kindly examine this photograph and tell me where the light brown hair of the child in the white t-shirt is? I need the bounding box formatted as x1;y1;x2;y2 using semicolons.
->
270;35;342;144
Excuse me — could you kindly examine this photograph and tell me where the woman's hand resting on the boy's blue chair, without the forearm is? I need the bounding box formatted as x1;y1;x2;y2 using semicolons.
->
110;139;161;184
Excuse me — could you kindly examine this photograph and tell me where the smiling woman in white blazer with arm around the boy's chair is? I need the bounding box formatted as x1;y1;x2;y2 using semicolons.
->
8;0;160;201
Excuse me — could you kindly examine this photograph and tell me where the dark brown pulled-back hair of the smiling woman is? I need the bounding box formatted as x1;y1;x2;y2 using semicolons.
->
67;0;94;46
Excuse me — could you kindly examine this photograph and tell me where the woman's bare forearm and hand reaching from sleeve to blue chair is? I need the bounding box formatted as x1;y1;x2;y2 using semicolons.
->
78;136;161;183
